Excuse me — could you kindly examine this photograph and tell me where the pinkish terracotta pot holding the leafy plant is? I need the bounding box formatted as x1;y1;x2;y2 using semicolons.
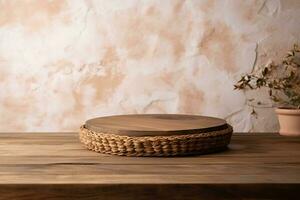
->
275;108;300;136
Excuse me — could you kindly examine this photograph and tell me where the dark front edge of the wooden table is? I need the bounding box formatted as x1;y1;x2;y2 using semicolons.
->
0;184;299;200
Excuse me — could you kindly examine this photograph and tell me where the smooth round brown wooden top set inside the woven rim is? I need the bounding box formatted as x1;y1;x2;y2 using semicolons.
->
85;114;227;136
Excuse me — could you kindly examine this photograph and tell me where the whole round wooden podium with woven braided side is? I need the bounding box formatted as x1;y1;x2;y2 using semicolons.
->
80;114;232;156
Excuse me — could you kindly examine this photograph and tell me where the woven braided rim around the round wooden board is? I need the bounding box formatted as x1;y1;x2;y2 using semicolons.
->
79;125;232;156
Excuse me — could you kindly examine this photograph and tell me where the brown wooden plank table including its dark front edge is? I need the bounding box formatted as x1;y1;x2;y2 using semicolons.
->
0;133;300;199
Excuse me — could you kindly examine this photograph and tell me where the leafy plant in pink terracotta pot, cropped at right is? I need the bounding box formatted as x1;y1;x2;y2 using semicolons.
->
234;44;300;136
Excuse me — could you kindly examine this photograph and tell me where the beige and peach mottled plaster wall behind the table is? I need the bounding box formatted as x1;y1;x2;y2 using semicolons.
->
0;0;300;131
